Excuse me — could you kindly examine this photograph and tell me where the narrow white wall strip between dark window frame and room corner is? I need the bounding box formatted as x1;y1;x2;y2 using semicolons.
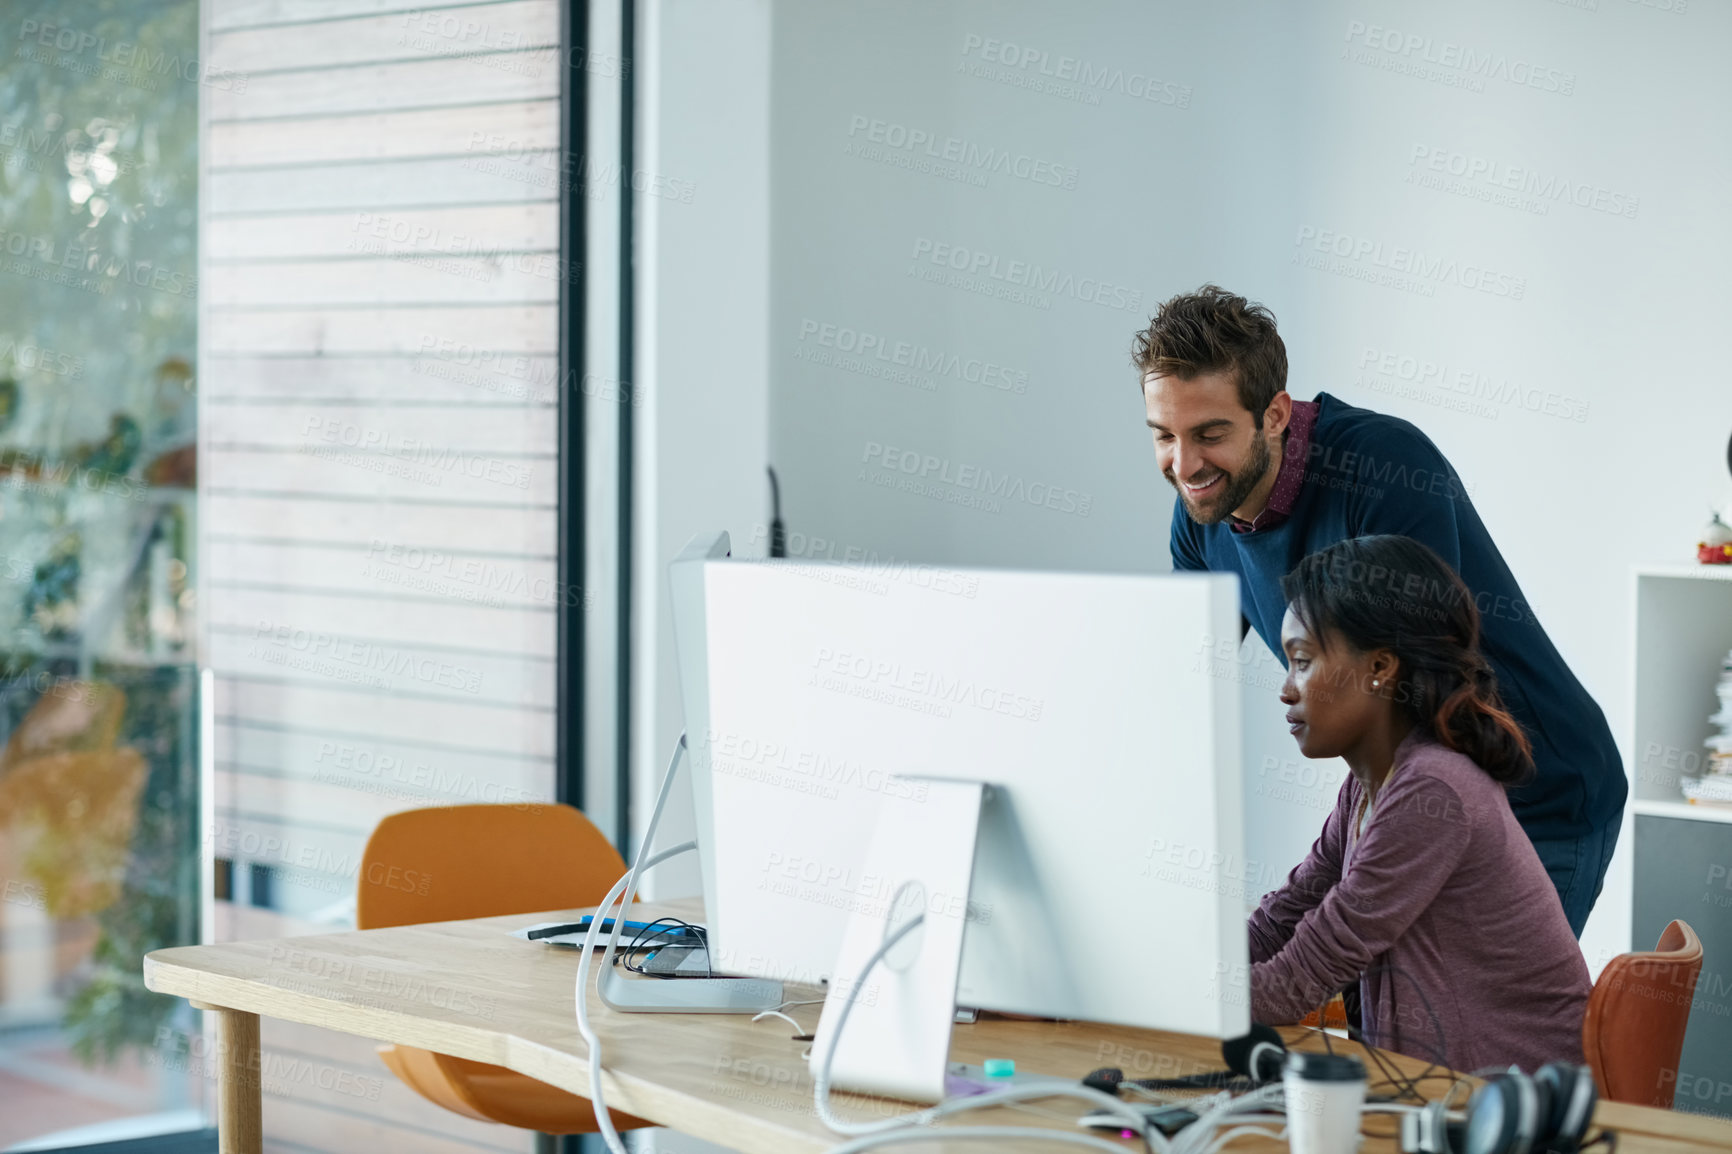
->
632;0;771;894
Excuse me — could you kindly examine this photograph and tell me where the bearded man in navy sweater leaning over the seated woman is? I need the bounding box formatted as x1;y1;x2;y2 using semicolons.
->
1133;284;1628;937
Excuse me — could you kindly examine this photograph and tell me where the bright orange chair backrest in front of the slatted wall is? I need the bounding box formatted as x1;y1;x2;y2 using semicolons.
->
355;804;625;929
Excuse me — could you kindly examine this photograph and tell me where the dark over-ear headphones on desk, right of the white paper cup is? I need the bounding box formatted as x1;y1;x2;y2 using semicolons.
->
1401;1062;1600;1154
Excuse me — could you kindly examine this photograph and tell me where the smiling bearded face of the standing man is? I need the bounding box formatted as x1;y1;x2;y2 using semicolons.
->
1143;369;1290;525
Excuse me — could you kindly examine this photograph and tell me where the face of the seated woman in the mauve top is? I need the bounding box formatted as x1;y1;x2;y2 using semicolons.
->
1282;608;1396;757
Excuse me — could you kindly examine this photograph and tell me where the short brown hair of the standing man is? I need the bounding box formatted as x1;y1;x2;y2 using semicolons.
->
1131;284;1287;428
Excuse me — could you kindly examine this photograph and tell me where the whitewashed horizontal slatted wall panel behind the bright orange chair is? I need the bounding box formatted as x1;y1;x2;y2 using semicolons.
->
201;0;557;1154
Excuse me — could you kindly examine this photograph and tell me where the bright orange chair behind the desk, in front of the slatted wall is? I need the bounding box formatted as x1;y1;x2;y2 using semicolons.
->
355;806;655;1133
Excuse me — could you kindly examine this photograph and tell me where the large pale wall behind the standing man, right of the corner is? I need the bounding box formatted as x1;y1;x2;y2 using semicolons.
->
758;0;1732;970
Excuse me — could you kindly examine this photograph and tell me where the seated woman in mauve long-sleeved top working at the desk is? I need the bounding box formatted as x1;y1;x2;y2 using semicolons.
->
1251;535;1590;1071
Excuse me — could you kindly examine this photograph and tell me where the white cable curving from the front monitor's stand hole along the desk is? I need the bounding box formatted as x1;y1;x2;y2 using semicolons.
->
812;915;1174;1154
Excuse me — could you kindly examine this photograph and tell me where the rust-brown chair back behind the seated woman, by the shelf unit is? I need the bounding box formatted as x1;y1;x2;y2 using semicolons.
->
1581;922;1703;1109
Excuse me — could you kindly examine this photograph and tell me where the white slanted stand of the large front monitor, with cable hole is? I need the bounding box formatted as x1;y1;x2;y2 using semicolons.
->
812;778;989;1102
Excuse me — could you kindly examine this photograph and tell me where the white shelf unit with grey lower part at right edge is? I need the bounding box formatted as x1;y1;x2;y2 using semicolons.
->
1630;565;1732;1112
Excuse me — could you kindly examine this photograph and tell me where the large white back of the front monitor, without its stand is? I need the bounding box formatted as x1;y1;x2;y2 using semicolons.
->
679;560;1254;1038
